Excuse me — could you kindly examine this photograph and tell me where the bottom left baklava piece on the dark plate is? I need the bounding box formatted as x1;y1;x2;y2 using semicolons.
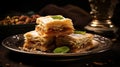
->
23;31;55;52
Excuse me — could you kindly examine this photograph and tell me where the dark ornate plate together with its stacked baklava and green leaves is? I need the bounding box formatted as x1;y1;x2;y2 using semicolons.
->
2;15;112;61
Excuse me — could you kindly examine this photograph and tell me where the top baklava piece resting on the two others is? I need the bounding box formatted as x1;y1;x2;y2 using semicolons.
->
35;15;74;36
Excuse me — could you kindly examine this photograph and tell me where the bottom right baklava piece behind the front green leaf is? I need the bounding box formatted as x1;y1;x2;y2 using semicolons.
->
56;33;94;53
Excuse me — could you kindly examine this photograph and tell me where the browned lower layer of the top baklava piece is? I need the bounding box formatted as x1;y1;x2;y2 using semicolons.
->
35;26;74;36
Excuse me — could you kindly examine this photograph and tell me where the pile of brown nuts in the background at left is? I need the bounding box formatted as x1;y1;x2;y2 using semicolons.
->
0;14;40;25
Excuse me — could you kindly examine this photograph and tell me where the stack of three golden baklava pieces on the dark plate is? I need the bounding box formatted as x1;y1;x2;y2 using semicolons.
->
23;15;93;52
